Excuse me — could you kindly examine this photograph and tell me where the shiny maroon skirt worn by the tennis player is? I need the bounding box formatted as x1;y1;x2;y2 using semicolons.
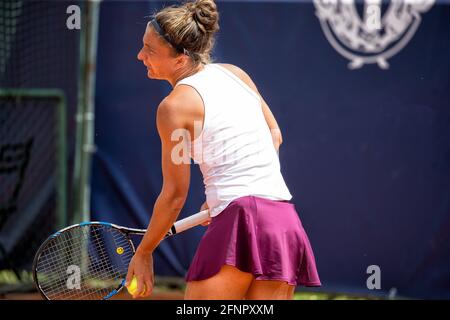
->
186;196;321;287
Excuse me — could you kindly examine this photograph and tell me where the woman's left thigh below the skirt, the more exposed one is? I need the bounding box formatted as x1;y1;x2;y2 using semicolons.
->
184;265;254;300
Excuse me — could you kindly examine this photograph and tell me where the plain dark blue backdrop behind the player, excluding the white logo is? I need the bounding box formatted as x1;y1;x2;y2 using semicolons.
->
91;1;450;298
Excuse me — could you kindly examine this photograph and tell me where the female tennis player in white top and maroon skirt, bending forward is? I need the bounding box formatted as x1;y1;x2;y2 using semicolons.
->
127;0;321;300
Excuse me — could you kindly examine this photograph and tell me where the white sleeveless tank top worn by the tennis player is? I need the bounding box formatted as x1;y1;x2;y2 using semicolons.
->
176;64;292;217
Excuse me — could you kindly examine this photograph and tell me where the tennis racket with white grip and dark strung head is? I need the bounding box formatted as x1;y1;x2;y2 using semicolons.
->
33;210;209;300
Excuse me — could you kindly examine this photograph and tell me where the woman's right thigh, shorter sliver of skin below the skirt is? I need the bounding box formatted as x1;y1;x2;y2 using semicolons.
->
245;280;295;300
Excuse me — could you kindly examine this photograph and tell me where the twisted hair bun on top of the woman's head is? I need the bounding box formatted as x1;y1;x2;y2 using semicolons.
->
188;0;219;33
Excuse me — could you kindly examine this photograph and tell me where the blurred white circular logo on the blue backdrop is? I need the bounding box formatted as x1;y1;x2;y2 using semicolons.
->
314;0;435;69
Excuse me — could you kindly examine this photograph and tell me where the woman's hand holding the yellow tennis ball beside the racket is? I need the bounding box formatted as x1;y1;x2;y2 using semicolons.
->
125;248;154;299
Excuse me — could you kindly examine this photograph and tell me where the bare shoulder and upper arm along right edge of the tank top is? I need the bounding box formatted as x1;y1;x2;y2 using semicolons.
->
221;64;283;152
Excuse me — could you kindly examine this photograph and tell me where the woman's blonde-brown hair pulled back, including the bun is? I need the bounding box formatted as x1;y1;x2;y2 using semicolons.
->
153;0;219;65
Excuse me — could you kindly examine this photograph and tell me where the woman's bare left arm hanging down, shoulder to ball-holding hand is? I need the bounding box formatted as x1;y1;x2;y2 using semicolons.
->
126;98;190;298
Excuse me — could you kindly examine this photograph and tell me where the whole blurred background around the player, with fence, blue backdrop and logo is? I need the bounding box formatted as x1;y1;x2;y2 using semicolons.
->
0;0;450;299
